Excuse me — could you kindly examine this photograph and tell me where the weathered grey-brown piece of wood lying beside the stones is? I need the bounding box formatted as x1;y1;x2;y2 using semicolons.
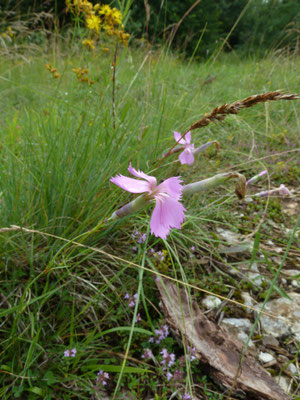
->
157;280;291;400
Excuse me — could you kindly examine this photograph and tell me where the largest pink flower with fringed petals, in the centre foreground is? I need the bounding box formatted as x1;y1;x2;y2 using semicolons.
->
110;164;186;239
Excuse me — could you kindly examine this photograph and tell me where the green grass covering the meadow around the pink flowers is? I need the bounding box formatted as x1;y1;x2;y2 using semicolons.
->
0;36;300;399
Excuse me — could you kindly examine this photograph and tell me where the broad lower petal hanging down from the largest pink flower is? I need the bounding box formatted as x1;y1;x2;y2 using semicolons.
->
150;196;186;239
